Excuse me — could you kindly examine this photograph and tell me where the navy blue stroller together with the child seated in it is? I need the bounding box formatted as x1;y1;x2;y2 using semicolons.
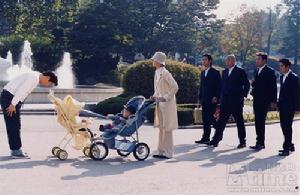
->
80;96;153;161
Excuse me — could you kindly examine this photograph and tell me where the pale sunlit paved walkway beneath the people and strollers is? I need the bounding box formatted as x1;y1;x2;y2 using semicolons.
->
0;115;300;195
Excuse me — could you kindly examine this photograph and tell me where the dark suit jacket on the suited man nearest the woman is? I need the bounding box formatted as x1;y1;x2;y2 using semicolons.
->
199;67;222;104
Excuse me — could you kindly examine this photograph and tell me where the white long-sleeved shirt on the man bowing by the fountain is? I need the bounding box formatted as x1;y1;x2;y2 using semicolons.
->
3;71;40;106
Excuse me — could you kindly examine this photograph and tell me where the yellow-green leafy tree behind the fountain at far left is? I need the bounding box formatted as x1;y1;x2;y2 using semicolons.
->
0;0;80;70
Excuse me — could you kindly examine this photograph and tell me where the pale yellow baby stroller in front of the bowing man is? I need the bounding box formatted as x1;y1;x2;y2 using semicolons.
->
48;91;94;160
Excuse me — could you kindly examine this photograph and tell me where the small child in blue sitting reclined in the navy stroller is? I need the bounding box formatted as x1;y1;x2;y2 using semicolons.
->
99;105;137;132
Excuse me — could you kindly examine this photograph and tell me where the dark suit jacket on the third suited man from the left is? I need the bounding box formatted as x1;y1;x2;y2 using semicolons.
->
251;66;277;106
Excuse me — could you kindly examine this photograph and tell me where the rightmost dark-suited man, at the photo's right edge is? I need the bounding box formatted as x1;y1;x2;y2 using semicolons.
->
278;59;300;156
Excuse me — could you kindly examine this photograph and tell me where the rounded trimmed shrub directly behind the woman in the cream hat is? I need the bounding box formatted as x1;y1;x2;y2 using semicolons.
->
122;60;200;104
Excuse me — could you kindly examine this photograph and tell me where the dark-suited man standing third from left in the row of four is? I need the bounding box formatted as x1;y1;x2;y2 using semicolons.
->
250;52;277;150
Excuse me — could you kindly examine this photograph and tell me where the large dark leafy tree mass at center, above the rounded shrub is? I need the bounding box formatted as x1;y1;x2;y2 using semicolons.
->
69;0;218;82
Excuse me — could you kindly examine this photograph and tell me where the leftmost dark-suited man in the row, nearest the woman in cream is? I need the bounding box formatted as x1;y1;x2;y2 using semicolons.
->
195;54;222;144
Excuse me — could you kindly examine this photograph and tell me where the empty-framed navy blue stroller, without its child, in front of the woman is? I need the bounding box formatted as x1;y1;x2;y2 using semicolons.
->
81;96;153;161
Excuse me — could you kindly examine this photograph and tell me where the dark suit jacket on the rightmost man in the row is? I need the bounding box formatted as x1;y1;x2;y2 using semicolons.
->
279;72;300;111
